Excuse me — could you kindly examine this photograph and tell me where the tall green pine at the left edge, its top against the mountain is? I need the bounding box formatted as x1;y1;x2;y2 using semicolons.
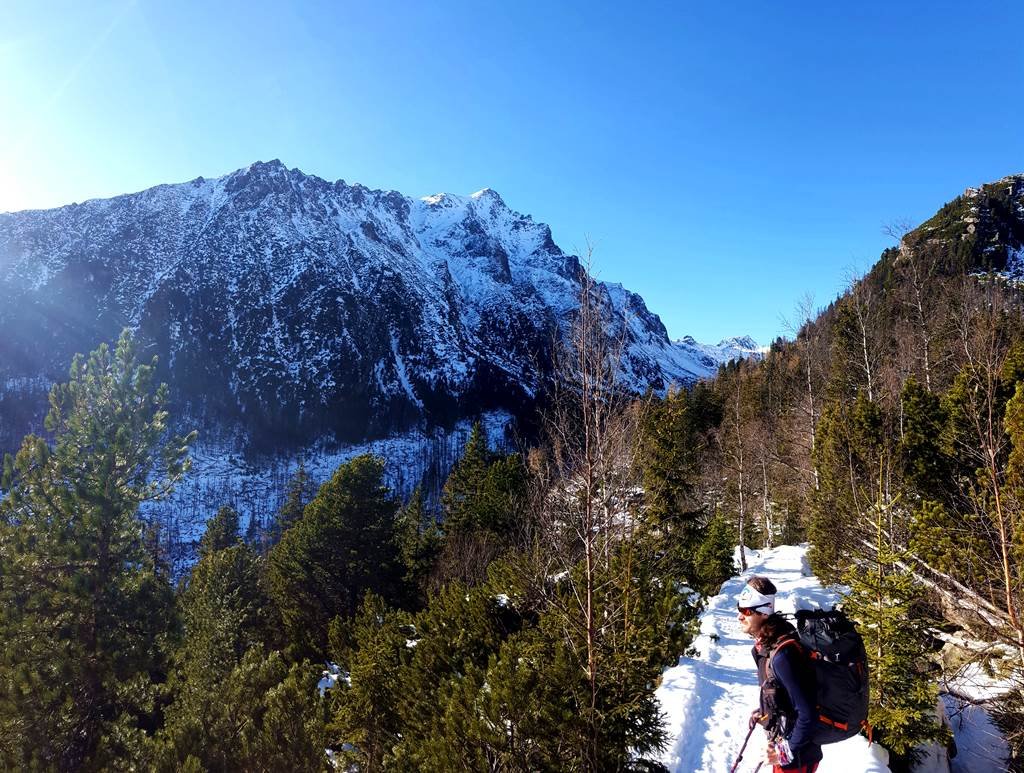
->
0;331;194;769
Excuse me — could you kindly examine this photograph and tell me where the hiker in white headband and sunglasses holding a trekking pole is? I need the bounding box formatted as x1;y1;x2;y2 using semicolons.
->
736;576;821;773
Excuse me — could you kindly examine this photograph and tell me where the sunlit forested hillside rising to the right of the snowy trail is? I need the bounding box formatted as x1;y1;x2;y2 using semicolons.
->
684;177;1024;769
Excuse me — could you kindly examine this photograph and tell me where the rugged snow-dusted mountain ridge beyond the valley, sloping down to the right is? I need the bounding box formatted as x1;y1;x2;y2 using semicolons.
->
0;161;756;445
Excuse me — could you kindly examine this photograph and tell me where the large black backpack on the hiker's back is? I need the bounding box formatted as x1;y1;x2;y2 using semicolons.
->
768;609;870;744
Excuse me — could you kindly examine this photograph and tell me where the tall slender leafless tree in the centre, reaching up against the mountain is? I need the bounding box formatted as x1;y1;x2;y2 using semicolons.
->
529;260;642;770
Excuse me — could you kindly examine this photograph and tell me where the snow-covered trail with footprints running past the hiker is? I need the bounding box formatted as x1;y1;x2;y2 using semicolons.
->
656;546;889;773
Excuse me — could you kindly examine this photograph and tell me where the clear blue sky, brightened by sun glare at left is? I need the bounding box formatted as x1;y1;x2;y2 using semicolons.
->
0;0;1024;343
